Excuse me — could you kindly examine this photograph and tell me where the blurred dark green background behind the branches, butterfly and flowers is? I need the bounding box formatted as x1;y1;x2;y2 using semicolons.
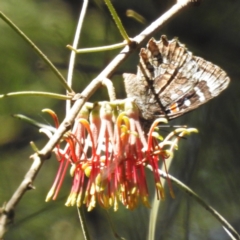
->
0;0;240;240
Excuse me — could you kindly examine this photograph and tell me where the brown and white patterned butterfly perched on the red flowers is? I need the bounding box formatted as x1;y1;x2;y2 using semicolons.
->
123;35;230;121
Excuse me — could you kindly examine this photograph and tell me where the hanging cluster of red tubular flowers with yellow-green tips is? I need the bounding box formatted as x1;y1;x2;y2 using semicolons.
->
45;100;197;211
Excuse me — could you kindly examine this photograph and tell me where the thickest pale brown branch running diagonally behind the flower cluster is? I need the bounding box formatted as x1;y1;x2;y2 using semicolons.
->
0;0;195;236
